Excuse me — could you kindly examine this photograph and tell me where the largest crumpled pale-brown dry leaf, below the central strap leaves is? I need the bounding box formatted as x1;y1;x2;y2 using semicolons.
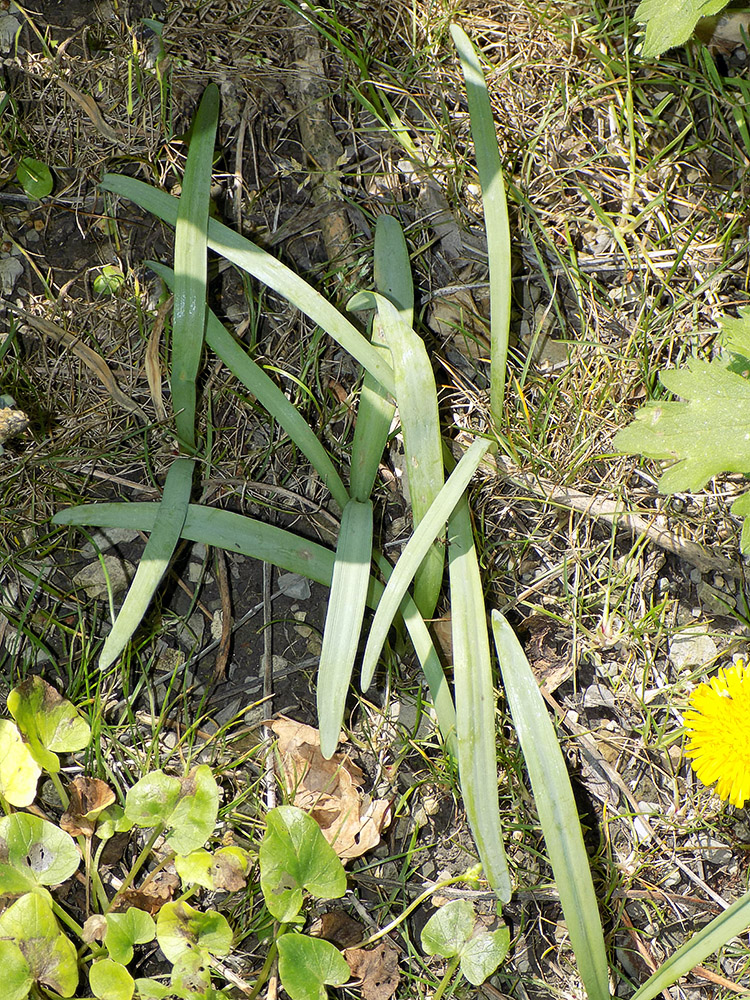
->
271;718;390;861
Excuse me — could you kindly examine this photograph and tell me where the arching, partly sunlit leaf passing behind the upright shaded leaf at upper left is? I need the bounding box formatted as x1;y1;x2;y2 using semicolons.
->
101;174;395;394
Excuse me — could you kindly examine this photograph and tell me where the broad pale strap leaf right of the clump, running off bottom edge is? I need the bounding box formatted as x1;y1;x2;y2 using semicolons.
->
492;611;610;1000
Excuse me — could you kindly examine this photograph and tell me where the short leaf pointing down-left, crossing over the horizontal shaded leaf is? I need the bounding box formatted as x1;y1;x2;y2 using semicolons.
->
99;458;193;670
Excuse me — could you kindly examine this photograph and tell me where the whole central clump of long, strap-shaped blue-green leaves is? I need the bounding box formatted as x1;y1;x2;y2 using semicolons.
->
55;29;511;900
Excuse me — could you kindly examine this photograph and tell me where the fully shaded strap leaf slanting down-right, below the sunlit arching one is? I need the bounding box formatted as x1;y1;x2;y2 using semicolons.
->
153;261;349;510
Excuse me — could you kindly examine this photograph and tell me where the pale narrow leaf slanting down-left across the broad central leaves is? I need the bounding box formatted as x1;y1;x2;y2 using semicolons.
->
362;438;490;691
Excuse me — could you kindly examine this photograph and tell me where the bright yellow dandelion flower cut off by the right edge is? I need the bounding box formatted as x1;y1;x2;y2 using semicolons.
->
685;660;750;808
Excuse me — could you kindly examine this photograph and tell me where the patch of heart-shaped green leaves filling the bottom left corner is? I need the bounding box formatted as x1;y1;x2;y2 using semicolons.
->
0;677;508;1000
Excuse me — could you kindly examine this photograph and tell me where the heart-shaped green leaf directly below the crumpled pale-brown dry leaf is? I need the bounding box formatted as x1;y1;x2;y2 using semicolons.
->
259;806;346;923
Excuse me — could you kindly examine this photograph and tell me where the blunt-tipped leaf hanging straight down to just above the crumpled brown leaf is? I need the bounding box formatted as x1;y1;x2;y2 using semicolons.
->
317;500;372;757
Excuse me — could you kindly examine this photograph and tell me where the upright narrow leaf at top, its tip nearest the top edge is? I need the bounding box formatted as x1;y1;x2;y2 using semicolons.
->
451;24;511;430
